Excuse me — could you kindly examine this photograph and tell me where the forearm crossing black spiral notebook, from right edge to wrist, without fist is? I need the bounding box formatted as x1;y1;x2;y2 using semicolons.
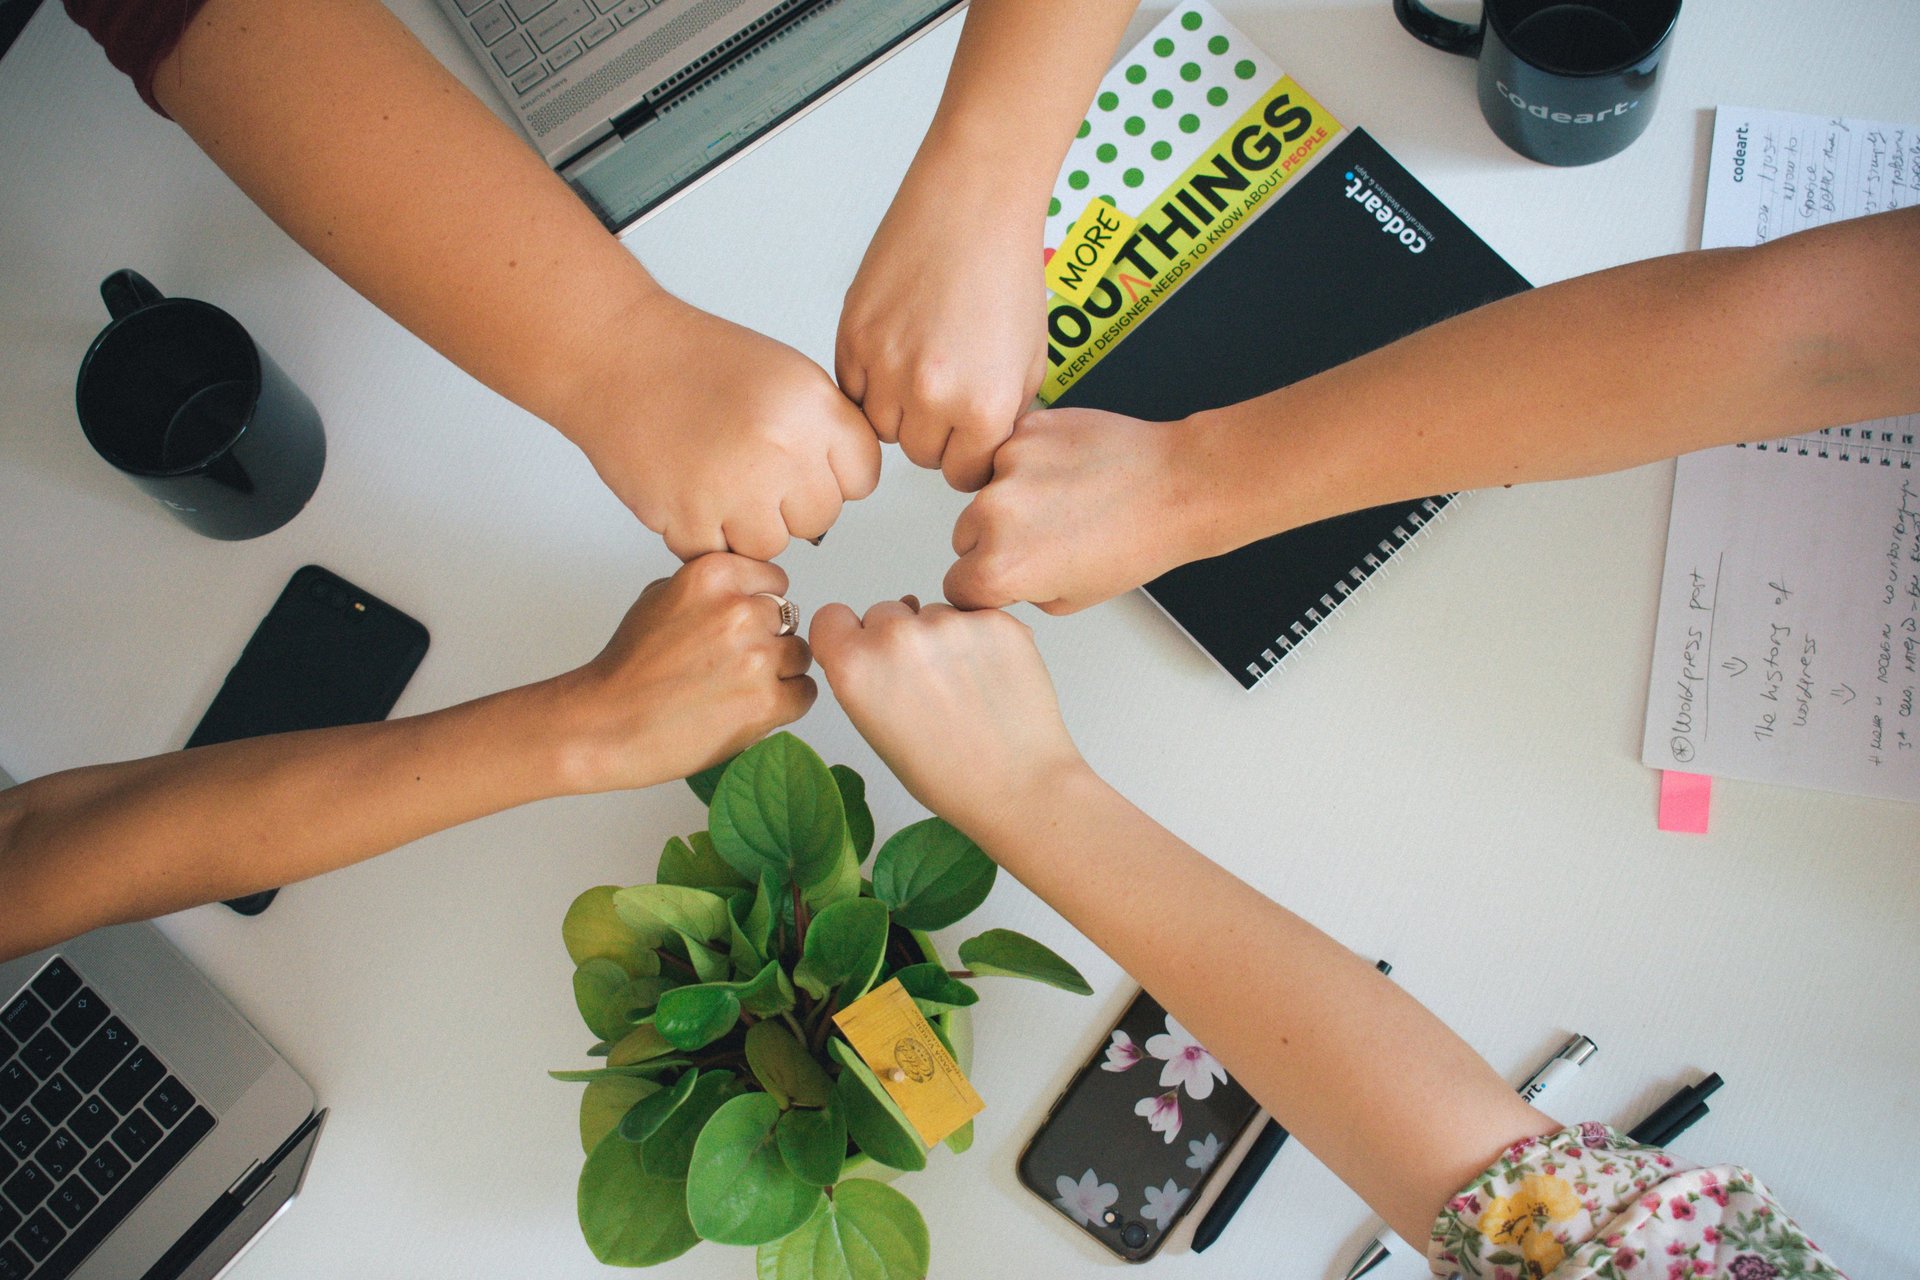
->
1188;209;1920;555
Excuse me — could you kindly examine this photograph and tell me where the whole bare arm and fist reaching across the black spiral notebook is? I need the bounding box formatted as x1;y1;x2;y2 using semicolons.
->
947;209;1920;612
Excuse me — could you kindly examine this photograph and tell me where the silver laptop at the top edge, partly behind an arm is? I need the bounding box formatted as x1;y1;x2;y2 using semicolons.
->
438;0;964;232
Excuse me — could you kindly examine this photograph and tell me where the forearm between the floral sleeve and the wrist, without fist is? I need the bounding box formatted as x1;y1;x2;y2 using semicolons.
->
970;766;1555;1240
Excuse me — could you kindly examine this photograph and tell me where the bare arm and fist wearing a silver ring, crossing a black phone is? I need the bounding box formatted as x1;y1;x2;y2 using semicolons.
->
0;557;814;960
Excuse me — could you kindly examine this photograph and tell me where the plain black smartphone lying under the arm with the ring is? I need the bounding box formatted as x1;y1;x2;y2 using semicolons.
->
186;564;426;915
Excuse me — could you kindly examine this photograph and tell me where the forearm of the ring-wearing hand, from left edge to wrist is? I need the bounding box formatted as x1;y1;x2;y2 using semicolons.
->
0;685;578;960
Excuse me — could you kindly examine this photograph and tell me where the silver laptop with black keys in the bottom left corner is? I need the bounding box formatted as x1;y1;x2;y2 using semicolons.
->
0;773;326;1280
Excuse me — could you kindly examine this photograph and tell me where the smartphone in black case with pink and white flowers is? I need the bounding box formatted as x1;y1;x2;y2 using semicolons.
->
1020;990;1260;1263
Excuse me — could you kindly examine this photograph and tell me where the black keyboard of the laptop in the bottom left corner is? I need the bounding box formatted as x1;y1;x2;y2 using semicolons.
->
0;956;213;1280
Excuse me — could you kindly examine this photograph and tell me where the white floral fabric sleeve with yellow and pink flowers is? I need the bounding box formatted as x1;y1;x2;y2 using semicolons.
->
1427;1125;1845;1280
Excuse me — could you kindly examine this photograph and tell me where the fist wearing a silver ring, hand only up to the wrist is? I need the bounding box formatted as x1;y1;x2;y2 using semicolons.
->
553;553;820;791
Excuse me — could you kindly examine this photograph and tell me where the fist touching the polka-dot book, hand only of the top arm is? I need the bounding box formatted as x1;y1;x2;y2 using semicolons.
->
833;147;1046;491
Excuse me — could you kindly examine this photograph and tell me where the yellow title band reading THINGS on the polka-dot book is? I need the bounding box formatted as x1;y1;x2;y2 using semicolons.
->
1041;75;1340;403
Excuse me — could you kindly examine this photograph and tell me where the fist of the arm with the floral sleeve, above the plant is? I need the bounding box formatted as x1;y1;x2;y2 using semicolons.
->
812;597;1081;841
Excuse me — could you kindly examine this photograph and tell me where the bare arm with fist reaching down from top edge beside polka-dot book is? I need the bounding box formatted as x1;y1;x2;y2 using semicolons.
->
835;0;1135;489
